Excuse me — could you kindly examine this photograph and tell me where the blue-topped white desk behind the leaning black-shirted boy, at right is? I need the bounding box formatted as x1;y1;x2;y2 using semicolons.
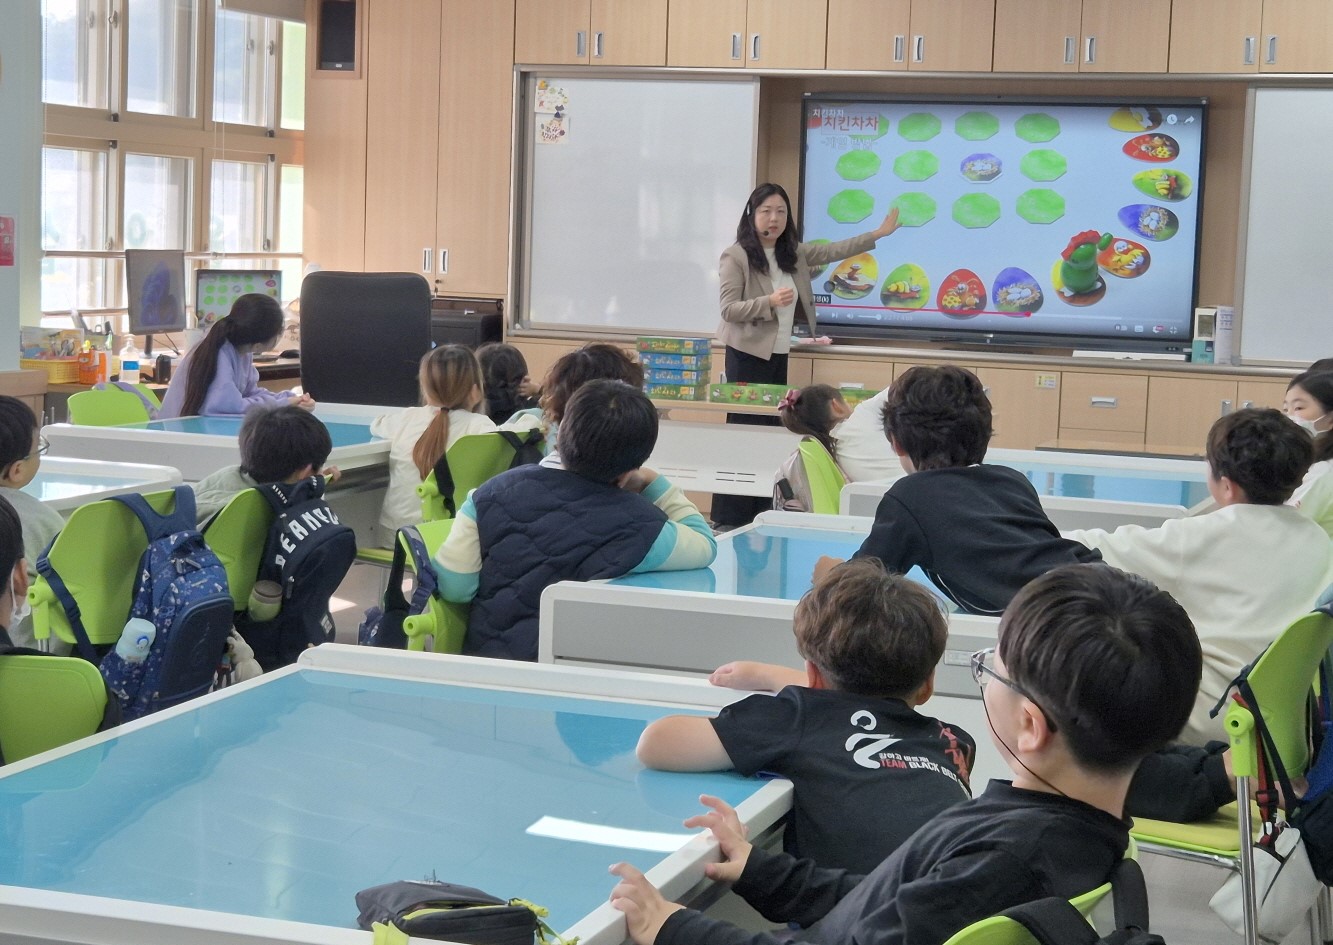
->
838;449;1213;530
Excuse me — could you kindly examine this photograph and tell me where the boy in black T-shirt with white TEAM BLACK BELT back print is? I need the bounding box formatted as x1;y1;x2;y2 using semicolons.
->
639;558;976;873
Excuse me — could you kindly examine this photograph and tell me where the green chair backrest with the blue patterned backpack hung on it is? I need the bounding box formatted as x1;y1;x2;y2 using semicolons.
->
28;487;175;645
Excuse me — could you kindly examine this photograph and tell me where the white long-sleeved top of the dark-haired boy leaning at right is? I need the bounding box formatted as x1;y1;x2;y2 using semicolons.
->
1062;505;1333;745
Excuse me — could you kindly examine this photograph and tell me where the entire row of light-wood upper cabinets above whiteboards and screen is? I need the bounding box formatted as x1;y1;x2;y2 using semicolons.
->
515;0;1333;73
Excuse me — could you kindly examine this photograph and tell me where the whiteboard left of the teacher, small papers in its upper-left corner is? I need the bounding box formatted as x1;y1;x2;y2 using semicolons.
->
517;73;758;335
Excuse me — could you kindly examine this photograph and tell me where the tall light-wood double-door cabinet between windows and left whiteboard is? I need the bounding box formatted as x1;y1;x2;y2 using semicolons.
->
364;0;513;296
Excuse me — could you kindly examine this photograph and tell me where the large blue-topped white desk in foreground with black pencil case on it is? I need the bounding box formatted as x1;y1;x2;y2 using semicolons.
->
0;644;790;945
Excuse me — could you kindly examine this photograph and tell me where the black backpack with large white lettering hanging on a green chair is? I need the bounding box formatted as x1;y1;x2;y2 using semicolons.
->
236;476;356;672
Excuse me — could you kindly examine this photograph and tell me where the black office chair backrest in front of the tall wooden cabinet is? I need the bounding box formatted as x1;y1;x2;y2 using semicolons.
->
301;272;431;407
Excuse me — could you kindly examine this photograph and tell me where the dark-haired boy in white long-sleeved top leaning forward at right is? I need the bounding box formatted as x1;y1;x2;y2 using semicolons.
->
1065;408;1333;745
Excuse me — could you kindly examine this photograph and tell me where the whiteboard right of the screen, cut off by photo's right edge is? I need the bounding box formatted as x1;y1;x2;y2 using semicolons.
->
1240;88;1333;365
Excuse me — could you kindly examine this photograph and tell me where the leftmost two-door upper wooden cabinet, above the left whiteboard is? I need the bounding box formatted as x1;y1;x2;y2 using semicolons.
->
517;0;667;65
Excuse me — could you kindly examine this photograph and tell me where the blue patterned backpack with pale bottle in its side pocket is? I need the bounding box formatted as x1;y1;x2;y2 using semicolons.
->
96;485;232;720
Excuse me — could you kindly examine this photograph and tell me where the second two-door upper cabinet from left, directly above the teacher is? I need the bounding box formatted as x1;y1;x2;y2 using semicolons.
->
667;0;829;69
